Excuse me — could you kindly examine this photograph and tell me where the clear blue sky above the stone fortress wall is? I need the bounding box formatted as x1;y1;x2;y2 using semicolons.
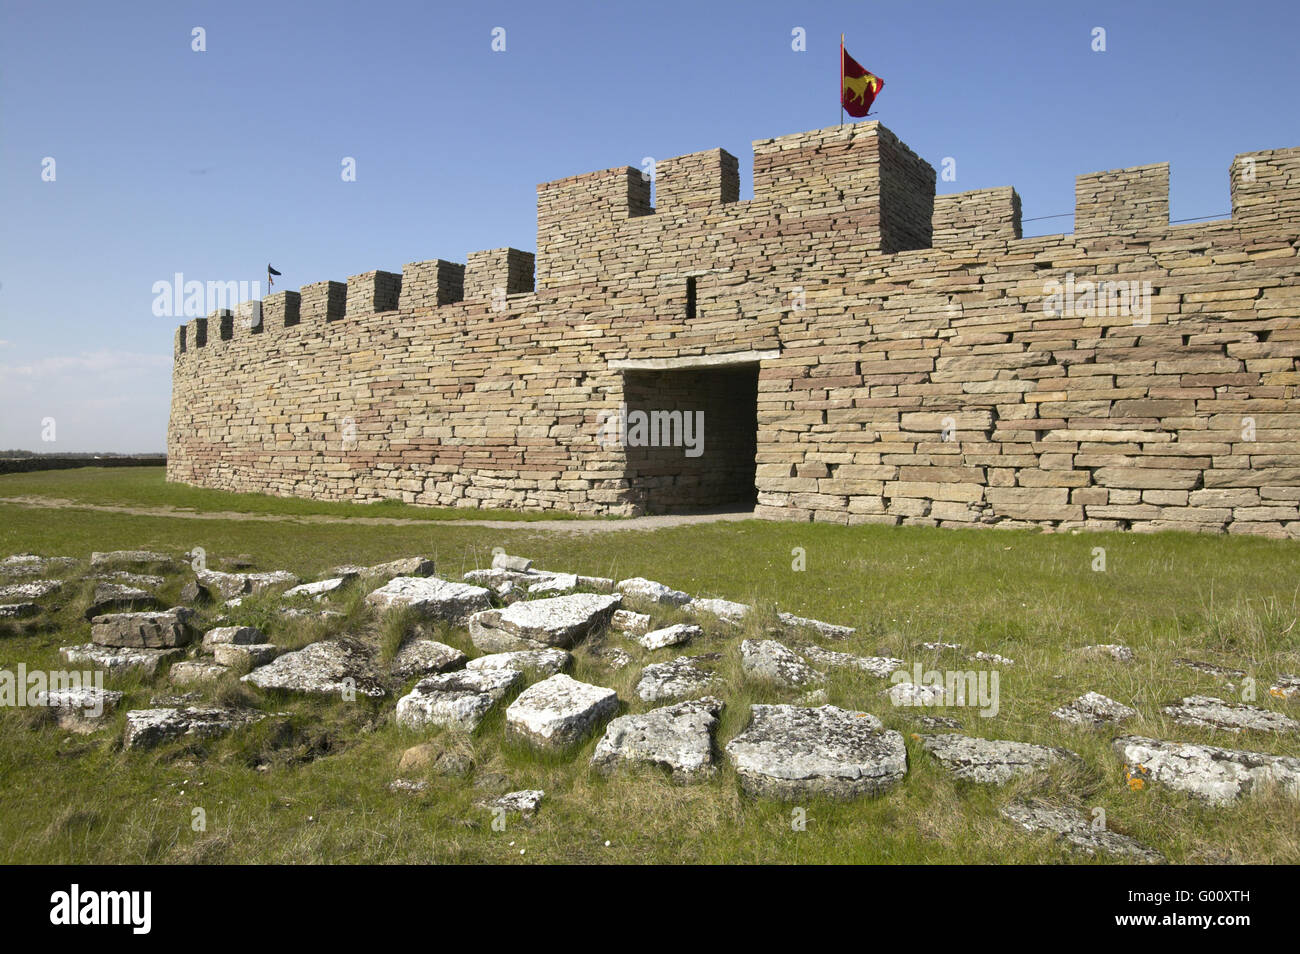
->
0;0;1300;452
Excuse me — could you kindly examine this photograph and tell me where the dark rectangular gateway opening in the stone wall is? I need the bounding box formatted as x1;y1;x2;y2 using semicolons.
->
623;363;758;513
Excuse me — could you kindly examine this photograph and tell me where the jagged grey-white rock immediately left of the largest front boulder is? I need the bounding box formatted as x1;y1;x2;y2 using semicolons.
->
592;697;723;782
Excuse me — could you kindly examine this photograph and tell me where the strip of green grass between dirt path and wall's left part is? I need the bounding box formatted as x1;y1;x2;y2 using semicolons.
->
0;467;579;521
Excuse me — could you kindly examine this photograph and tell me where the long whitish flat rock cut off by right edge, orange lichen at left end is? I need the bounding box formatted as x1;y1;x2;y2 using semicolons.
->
1112;736;1300;805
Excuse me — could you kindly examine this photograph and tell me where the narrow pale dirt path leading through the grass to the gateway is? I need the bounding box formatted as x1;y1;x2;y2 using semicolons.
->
0;496;754;533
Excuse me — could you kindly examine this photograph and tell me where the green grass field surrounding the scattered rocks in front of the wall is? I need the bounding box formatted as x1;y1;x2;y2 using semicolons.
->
0;468;1300;863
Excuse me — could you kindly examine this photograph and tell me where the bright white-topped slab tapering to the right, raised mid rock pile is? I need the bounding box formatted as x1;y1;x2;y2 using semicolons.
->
469;593;621;652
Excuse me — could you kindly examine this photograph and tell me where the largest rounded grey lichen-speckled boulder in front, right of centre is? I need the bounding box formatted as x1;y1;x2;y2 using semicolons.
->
727;706;907;801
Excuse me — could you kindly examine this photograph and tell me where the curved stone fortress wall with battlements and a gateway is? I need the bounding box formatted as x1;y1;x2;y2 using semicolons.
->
168;122;1300;538
